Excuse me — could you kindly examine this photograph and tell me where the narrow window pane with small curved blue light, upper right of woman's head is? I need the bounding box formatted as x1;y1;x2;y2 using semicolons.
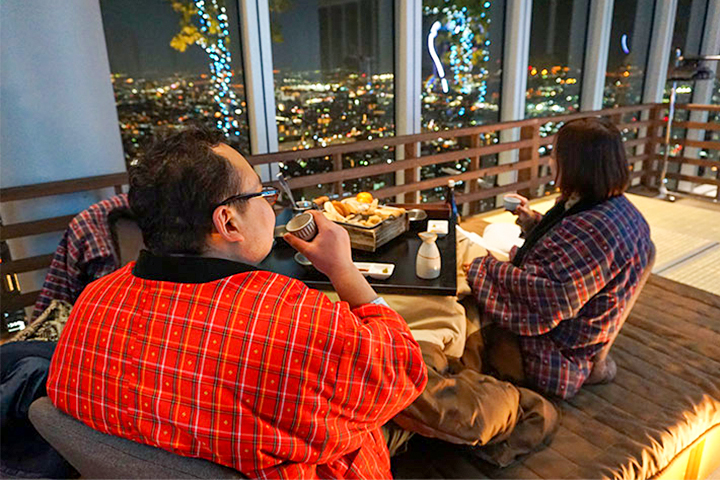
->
603;0;655;108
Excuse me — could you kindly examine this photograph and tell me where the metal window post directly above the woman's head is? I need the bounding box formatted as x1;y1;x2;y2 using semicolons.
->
580;0;613;112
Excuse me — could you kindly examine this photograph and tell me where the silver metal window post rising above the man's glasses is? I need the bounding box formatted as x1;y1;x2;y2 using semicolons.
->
238;0;279;182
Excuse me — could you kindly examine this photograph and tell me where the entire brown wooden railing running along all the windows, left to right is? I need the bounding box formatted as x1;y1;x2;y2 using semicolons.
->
0;104;720;311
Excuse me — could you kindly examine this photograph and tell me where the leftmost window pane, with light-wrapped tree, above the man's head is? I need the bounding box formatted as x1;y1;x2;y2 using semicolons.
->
100;0;250;162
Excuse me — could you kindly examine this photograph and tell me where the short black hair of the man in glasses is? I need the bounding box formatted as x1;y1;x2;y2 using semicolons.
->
128;127;241;255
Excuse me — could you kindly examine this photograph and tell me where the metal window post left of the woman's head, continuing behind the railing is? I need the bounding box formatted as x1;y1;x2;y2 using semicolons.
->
496;0;532;202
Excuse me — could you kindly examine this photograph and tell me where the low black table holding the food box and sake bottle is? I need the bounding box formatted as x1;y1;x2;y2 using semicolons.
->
260;210;457;296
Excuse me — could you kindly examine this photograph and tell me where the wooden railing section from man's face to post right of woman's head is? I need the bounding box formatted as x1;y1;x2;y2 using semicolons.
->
249;104;661;208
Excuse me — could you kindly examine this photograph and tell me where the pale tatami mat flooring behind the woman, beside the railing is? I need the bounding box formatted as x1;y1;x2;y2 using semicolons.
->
467;194;720;295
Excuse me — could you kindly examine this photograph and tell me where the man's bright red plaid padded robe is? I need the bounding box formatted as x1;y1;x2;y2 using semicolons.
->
47;252;427;478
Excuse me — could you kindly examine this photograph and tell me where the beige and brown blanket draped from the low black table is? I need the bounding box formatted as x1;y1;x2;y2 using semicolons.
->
330;232;558;466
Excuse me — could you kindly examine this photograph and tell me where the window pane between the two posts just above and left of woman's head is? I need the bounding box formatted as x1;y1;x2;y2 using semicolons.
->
525;0;590;118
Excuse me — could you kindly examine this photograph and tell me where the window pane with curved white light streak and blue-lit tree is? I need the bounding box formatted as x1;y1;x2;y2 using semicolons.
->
422;0;505;131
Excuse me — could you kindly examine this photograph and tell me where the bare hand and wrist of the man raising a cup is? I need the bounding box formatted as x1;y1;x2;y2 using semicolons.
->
283;210;377;307
